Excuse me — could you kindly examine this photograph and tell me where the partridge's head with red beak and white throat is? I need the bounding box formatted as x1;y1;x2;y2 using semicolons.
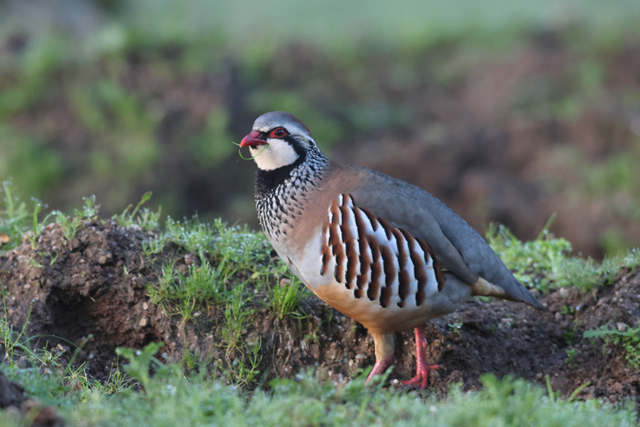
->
240;111;317;171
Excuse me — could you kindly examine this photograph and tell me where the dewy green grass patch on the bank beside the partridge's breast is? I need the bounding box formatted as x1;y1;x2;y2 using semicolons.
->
143;214;305;320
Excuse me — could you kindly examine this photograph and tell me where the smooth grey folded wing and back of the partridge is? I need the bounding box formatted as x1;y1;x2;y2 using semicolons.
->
350;166;542;308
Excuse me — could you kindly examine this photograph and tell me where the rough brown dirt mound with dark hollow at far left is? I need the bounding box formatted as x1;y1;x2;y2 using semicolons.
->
0;222;163;376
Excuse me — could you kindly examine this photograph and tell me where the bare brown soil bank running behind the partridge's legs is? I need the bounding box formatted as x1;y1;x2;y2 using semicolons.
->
0;220;640;410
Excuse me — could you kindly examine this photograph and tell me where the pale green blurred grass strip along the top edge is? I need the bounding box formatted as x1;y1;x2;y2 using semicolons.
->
126;0;640;49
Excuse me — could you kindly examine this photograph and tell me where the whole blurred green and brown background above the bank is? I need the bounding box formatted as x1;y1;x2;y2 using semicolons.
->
0;0;640;257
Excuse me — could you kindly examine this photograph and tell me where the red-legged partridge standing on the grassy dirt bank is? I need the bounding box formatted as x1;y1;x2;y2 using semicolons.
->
240;111;542;389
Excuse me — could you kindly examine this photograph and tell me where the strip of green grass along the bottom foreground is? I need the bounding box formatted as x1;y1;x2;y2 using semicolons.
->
0;344;637;427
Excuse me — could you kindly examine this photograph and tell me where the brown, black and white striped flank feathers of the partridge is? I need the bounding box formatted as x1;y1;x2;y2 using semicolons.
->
320;194;445;308
